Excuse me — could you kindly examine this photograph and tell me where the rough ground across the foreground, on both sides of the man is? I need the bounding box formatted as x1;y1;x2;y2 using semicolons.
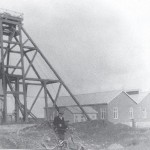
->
0;121;150;150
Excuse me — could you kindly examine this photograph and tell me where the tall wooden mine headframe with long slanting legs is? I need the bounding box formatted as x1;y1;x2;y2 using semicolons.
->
0;10;89;122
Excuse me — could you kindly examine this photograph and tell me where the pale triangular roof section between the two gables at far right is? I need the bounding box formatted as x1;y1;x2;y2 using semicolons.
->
129;92;150;104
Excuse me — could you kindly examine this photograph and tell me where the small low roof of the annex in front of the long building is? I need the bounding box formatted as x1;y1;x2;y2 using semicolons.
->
67;106;98;114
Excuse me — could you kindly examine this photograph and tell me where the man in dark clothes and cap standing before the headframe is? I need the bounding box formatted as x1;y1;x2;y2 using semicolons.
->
53;111;67;140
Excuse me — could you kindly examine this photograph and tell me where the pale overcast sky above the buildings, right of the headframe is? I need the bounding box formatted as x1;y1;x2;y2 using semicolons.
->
0;0;150;93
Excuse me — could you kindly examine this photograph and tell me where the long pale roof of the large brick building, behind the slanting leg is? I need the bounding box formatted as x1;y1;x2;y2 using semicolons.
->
53;91;122;106
